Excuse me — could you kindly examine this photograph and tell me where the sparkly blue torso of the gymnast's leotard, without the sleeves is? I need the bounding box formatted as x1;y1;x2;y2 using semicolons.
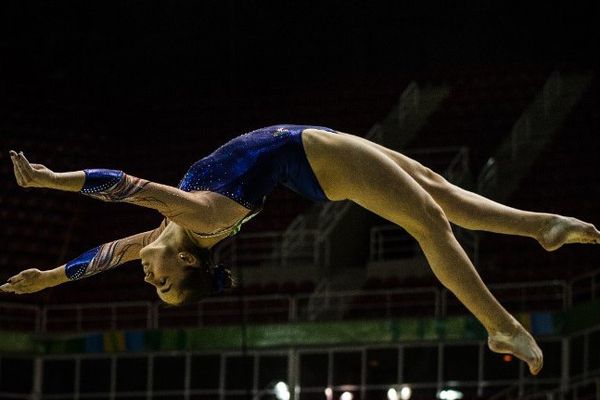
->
179;125;335;210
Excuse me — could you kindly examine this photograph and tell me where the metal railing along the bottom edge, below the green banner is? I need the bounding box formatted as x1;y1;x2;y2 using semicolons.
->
0;327;600;400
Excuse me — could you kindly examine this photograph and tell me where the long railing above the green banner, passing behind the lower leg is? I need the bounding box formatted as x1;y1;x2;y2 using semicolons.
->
0;270;600;333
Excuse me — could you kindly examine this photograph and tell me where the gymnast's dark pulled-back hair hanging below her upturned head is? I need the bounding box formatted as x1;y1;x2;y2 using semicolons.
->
178;246;236;306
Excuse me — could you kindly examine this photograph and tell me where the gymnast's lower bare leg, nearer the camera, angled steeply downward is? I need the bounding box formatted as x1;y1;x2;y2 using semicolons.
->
305;133;543;374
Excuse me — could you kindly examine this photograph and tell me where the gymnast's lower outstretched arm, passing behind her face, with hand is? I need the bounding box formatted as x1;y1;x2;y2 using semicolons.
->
0;220;166;294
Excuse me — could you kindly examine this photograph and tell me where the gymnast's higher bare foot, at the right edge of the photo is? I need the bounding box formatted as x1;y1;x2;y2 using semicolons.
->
538;215;600;251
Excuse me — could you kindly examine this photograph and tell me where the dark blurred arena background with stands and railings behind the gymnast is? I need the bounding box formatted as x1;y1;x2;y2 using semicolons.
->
0;0;600;400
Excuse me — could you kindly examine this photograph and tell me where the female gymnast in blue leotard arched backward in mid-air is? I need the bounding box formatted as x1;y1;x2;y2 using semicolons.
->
0;125;600;374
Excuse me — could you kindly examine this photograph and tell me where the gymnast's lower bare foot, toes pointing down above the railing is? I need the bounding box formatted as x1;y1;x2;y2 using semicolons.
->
488;323;544;375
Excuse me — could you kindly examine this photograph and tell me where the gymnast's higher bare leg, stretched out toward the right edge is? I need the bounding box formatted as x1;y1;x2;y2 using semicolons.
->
340;135;600;251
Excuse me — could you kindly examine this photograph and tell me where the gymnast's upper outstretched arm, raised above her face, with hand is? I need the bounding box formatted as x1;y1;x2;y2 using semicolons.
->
10;151;213;231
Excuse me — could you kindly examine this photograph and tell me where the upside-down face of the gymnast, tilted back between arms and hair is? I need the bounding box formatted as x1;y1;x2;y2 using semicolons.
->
140;244;194;305
